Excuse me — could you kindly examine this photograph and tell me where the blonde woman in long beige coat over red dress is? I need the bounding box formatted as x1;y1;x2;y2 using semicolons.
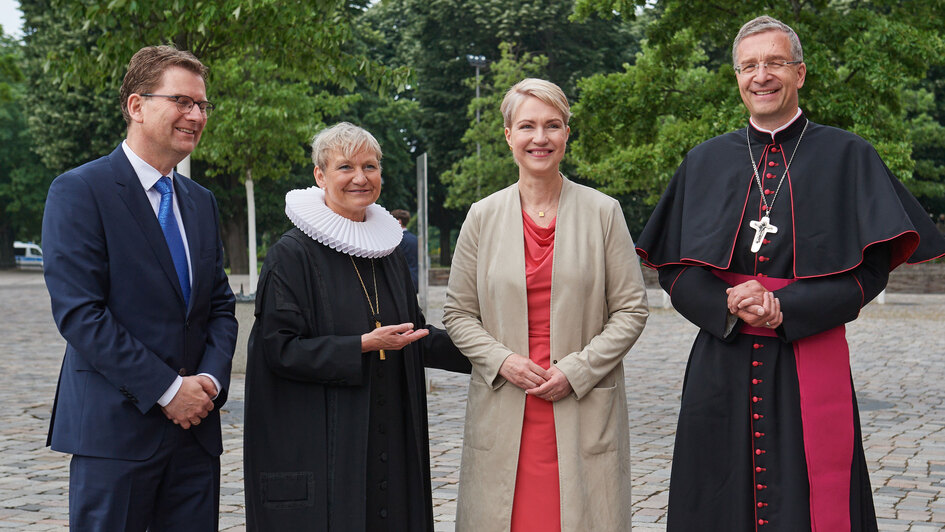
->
443;79;648;532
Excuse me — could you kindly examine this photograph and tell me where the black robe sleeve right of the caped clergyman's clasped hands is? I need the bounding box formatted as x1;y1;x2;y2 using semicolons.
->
775;243;891;342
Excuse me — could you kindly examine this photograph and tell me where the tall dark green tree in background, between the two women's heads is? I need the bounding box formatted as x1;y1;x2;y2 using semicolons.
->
367;0;635;264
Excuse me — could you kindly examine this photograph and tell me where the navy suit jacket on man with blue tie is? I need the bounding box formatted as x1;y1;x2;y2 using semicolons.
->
43;146;237;460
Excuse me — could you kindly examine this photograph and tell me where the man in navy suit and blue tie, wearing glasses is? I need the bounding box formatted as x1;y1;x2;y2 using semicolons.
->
43;46;237;531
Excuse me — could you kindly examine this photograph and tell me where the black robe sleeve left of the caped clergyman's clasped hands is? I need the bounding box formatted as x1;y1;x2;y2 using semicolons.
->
659;266;738;340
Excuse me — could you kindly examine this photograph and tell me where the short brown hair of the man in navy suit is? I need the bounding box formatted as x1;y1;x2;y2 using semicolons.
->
118;46;207;124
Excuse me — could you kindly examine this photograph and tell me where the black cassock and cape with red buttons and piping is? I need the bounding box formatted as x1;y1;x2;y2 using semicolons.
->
637;115;945;532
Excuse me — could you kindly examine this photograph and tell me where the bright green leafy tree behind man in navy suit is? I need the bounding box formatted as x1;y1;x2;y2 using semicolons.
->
22;0;406;273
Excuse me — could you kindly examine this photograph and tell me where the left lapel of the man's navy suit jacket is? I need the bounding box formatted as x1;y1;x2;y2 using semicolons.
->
108;145;184;305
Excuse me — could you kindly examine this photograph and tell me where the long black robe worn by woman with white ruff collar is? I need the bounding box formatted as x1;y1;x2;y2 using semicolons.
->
243;229;470;532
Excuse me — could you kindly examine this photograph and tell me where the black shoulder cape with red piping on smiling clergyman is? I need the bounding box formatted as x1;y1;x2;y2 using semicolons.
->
637;115;945;278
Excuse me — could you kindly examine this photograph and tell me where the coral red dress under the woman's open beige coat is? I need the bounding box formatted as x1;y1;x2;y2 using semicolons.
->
512;211;561;532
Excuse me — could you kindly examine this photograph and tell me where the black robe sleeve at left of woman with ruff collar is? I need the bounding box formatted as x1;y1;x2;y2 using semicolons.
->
253;249;364;386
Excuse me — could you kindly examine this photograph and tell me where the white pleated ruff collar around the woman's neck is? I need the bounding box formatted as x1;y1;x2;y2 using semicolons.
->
285;186;404;259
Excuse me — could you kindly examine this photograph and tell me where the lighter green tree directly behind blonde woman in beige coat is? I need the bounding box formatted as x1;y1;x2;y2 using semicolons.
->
441;43;548;210
